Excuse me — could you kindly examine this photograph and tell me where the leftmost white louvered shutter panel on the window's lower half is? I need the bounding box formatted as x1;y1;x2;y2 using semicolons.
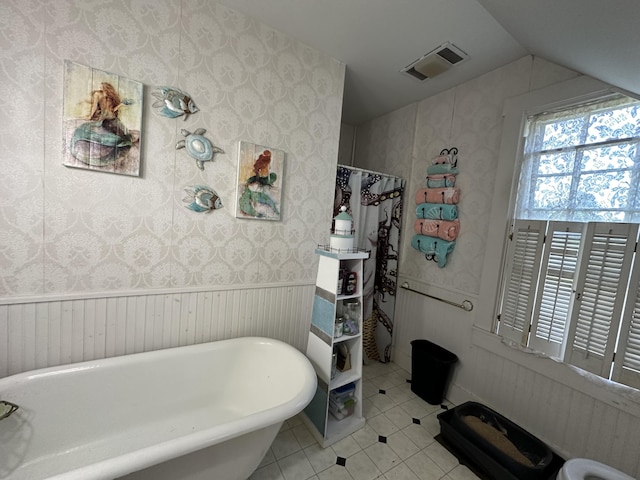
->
498;220;547;345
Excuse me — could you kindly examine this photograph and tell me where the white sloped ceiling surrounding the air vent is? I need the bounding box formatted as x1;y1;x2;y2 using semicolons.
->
221;0;640;126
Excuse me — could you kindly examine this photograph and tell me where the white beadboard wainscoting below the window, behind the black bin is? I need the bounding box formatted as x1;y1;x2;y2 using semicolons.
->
393;276;640;478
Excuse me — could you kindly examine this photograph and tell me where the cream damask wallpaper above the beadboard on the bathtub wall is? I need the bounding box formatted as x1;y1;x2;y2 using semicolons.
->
0;0;344;299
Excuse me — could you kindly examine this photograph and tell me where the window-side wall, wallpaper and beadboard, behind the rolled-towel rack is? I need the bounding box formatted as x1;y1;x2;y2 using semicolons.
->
356;57;640;478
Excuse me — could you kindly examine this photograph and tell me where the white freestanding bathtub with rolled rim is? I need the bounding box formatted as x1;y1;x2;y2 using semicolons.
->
0;337;316;480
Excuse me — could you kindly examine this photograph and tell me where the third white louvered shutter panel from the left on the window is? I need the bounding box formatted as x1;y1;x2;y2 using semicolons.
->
565;223;638;378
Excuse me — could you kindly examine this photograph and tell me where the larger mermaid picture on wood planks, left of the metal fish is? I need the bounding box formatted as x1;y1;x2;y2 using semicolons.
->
63;60;143;177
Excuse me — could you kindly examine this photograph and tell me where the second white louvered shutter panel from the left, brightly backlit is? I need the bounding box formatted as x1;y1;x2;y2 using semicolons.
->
529;222;586;357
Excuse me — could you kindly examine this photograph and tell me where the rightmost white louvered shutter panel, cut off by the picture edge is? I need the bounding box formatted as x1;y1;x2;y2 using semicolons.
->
611;259;640;388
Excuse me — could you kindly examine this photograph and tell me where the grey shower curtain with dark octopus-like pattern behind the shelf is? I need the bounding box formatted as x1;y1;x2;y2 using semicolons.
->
333;165;405;363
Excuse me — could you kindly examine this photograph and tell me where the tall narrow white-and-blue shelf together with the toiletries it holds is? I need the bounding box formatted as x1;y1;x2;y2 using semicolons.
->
303;248;369;447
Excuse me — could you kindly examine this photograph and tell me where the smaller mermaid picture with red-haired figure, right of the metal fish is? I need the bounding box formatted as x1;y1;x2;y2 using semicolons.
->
236;141;285;220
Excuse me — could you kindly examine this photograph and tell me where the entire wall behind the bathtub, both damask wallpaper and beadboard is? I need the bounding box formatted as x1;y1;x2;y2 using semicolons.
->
0;0;345;375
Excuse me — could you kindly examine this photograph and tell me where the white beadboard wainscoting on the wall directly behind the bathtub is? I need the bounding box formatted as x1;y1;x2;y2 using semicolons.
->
0;284;315;377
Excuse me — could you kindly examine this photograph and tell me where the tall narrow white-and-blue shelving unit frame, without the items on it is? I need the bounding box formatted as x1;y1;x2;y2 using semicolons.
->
303;247;369;447
